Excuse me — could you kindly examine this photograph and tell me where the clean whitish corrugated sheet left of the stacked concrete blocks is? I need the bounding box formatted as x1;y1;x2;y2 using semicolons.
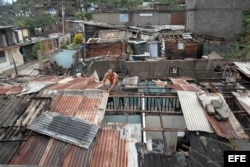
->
177;91;213;133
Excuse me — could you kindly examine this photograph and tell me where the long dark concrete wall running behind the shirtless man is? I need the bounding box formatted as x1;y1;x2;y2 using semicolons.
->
87;59;246;79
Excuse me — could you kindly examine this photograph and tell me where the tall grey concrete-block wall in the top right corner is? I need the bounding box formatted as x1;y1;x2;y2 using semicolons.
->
186;0;250;39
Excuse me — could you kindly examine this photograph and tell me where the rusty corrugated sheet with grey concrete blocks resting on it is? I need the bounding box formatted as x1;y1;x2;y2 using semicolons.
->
204;93;249;139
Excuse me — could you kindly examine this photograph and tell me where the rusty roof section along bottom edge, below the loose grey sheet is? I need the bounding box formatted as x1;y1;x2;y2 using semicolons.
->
9;124;141;167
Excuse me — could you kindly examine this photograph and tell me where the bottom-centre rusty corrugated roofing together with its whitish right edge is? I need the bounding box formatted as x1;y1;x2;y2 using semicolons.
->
90;123;141;167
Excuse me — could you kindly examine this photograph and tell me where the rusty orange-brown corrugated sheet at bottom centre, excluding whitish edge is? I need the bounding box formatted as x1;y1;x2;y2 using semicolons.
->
90;129;128;167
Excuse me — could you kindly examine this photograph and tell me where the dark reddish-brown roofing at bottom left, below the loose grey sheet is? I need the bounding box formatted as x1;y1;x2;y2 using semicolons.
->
9;135;92;167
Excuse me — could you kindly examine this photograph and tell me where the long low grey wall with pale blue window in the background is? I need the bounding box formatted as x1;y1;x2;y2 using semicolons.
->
93;11;185;26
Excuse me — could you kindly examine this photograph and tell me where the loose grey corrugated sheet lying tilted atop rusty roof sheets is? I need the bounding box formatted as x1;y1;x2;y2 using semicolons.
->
28;112;99;149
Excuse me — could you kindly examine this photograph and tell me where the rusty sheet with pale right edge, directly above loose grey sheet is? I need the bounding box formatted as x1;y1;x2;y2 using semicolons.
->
51;90;108;125
